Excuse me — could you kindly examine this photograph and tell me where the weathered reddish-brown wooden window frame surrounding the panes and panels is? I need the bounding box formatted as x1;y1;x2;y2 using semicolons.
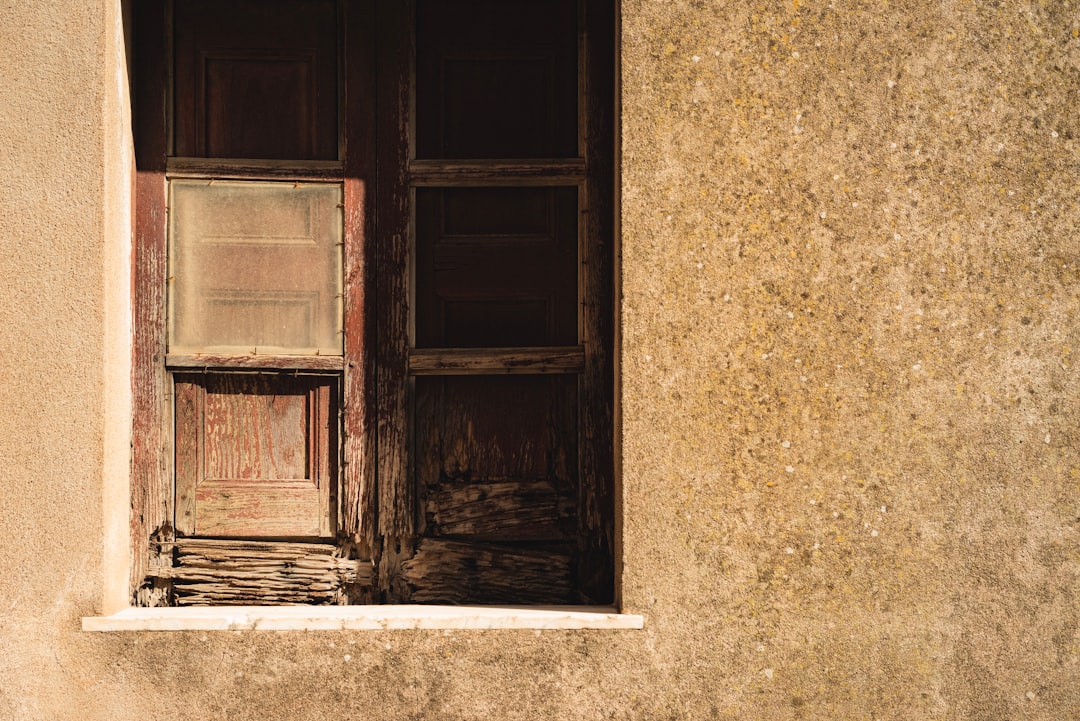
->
130;0;617;606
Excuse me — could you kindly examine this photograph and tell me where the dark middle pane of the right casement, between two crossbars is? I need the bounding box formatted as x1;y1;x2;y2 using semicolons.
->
416;188;578;348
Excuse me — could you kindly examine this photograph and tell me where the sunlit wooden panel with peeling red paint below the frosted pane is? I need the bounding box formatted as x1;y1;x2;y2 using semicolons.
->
175;373;337;536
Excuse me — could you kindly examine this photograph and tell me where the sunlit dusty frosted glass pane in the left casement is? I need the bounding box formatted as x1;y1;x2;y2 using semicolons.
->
168;180;342;355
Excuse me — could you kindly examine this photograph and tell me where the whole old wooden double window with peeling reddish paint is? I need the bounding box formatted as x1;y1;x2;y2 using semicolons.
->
132;0;615;606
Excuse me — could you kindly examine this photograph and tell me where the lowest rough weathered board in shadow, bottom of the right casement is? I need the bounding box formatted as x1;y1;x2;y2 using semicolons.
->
403;539;577;604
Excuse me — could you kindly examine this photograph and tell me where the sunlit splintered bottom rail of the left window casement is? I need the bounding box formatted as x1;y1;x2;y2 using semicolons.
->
151;539;372;606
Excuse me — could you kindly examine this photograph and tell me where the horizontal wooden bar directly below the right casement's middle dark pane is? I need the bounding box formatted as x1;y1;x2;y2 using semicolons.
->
408;345;585;376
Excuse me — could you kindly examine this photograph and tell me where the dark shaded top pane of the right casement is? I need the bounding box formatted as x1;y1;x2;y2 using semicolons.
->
416;0;578;158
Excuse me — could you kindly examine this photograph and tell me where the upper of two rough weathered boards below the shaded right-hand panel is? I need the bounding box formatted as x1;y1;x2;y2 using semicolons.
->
426;480;575;541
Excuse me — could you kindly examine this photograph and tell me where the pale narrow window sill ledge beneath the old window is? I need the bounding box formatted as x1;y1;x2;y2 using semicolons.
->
82;606;645;631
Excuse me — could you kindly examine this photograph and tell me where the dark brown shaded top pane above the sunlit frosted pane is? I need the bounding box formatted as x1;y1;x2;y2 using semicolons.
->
174;0;338;160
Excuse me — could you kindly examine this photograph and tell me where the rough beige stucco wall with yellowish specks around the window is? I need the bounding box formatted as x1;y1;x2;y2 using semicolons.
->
0;0;1080;721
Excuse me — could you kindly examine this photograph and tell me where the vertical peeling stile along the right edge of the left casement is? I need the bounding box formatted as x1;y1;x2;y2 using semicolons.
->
341;0;378;556
